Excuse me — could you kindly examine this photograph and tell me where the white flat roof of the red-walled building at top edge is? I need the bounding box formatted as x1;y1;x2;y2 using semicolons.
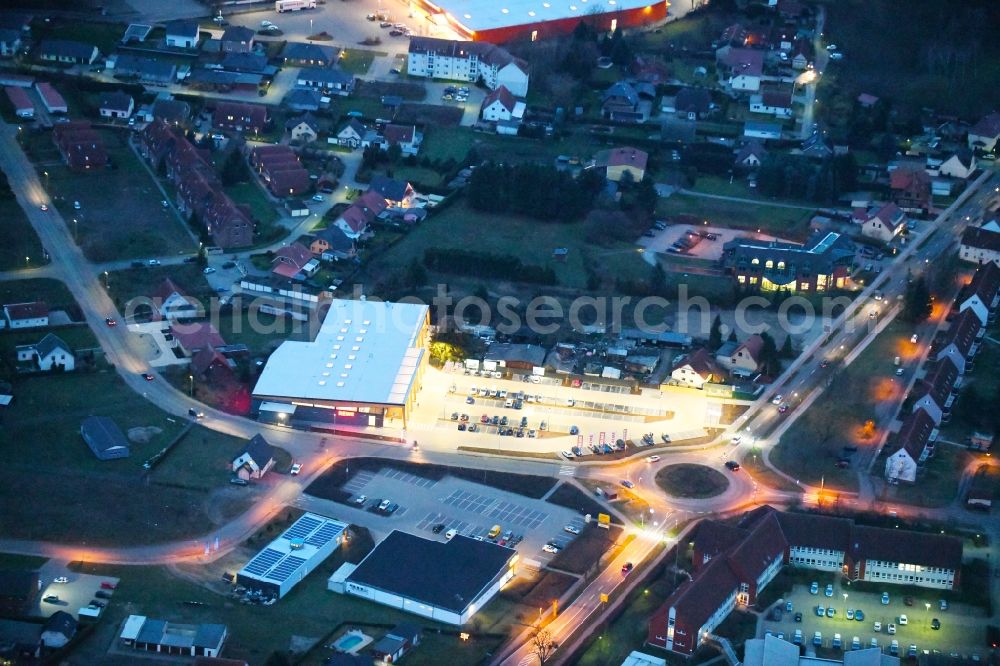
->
425;0;652;31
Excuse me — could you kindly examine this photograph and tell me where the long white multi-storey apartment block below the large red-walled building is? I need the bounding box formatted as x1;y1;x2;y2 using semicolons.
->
406;36;529;97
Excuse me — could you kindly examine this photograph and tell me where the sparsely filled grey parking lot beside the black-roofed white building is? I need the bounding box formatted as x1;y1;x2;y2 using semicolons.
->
320;468;584;562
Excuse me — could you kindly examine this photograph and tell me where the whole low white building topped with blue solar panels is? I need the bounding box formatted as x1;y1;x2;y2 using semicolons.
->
236;513;347;599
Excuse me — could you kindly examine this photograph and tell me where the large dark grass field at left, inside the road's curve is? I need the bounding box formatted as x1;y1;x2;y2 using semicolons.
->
0;371;250;546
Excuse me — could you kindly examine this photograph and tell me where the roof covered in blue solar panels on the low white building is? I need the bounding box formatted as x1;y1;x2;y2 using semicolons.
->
237;513;347;585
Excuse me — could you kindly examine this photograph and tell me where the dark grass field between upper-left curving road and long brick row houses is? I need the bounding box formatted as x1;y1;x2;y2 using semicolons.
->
33;130;197;261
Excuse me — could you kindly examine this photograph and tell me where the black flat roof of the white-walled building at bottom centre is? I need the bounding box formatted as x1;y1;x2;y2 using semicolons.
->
346;530;517;613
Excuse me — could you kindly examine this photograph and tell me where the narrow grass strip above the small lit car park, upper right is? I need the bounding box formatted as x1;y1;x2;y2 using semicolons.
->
656;194;811;240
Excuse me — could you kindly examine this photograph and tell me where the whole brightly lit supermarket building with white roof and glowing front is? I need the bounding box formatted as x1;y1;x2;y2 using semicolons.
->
253;300;429;428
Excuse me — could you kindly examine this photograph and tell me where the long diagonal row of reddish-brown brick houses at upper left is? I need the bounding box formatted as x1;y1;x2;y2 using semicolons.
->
138;119;254;249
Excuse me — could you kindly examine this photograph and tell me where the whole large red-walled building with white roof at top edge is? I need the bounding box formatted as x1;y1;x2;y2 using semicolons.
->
413;0;672;44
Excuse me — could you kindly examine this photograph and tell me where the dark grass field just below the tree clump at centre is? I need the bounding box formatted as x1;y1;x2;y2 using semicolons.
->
369;202;652;288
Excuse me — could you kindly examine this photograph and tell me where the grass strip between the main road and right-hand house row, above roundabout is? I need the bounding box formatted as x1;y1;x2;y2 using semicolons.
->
770;319;916;490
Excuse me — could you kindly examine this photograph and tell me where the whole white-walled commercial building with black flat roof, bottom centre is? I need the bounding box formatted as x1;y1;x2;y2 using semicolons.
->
327;530;517;625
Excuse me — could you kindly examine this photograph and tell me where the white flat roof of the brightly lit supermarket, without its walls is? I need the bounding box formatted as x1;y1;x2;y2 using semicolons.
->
253;300;429;405
